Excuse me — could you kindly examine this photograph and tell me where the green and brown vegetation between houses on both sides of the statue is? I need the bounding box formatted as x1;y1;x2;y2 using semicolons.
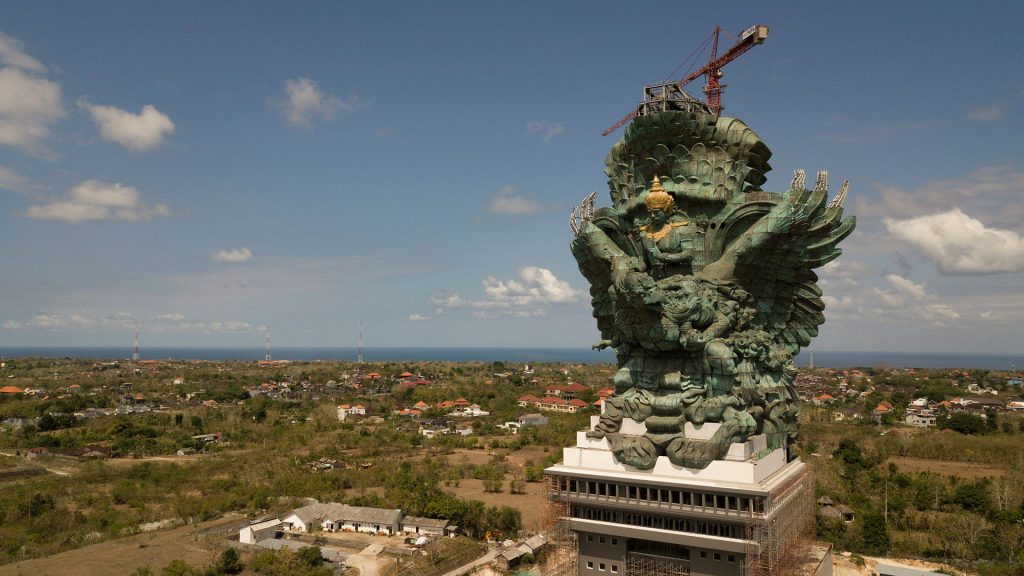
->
0;359;1024;575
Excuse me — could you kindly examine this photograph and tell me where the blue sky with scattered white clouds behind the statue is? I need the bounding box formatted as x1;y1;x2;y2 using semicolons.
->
0;2;1024;354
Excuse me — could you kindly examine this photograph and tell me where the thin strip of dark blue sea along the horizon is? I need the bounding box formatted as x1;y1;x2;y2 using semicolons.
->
0;346;1024;370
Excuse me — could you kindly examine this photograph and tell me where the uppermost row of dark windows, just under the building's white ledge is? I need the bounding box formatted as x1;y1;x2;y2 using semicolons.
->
558;478;765;513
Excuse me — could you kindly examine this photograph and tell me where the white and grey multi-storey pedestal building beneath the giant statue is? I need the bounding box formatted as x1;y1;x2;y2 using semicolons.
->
545;416;831;576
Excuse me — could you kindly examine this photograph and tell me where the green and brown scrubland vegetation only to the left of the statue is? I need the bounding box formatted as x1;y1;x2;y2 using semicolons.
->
0;359;593;561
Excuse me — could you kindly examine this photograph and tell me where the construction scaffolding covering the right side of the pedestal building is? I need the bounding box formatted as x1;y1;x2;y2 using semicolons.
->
744;468;814;576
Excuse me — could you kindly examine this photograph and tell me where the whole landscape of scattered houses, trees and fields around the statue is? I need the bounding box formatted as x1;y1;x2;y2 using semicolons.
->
0;358;1024;576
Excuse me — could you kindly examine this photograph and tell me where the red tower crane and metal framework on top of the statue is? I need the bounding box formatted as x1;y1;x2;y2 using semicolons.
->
601;24;768;136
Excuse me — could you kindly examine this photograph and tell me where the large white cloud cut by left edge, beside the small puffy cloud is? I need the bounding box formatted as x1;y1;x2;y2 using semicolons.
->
0;68;65;154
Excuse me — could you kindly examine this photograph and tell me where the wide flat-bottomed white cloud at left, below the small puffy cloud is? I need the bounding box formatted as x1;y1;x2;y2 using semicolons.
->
25;180;171;223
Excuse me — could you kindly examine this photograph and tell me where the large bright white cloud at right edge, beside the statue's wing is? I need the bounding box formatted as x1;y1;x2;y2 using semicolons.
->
883;208;1024;274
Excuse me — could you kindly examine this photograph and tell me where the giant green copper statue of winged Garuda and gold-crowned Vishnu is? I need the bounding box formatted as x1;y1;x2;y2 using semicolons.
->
570;111;856;469
